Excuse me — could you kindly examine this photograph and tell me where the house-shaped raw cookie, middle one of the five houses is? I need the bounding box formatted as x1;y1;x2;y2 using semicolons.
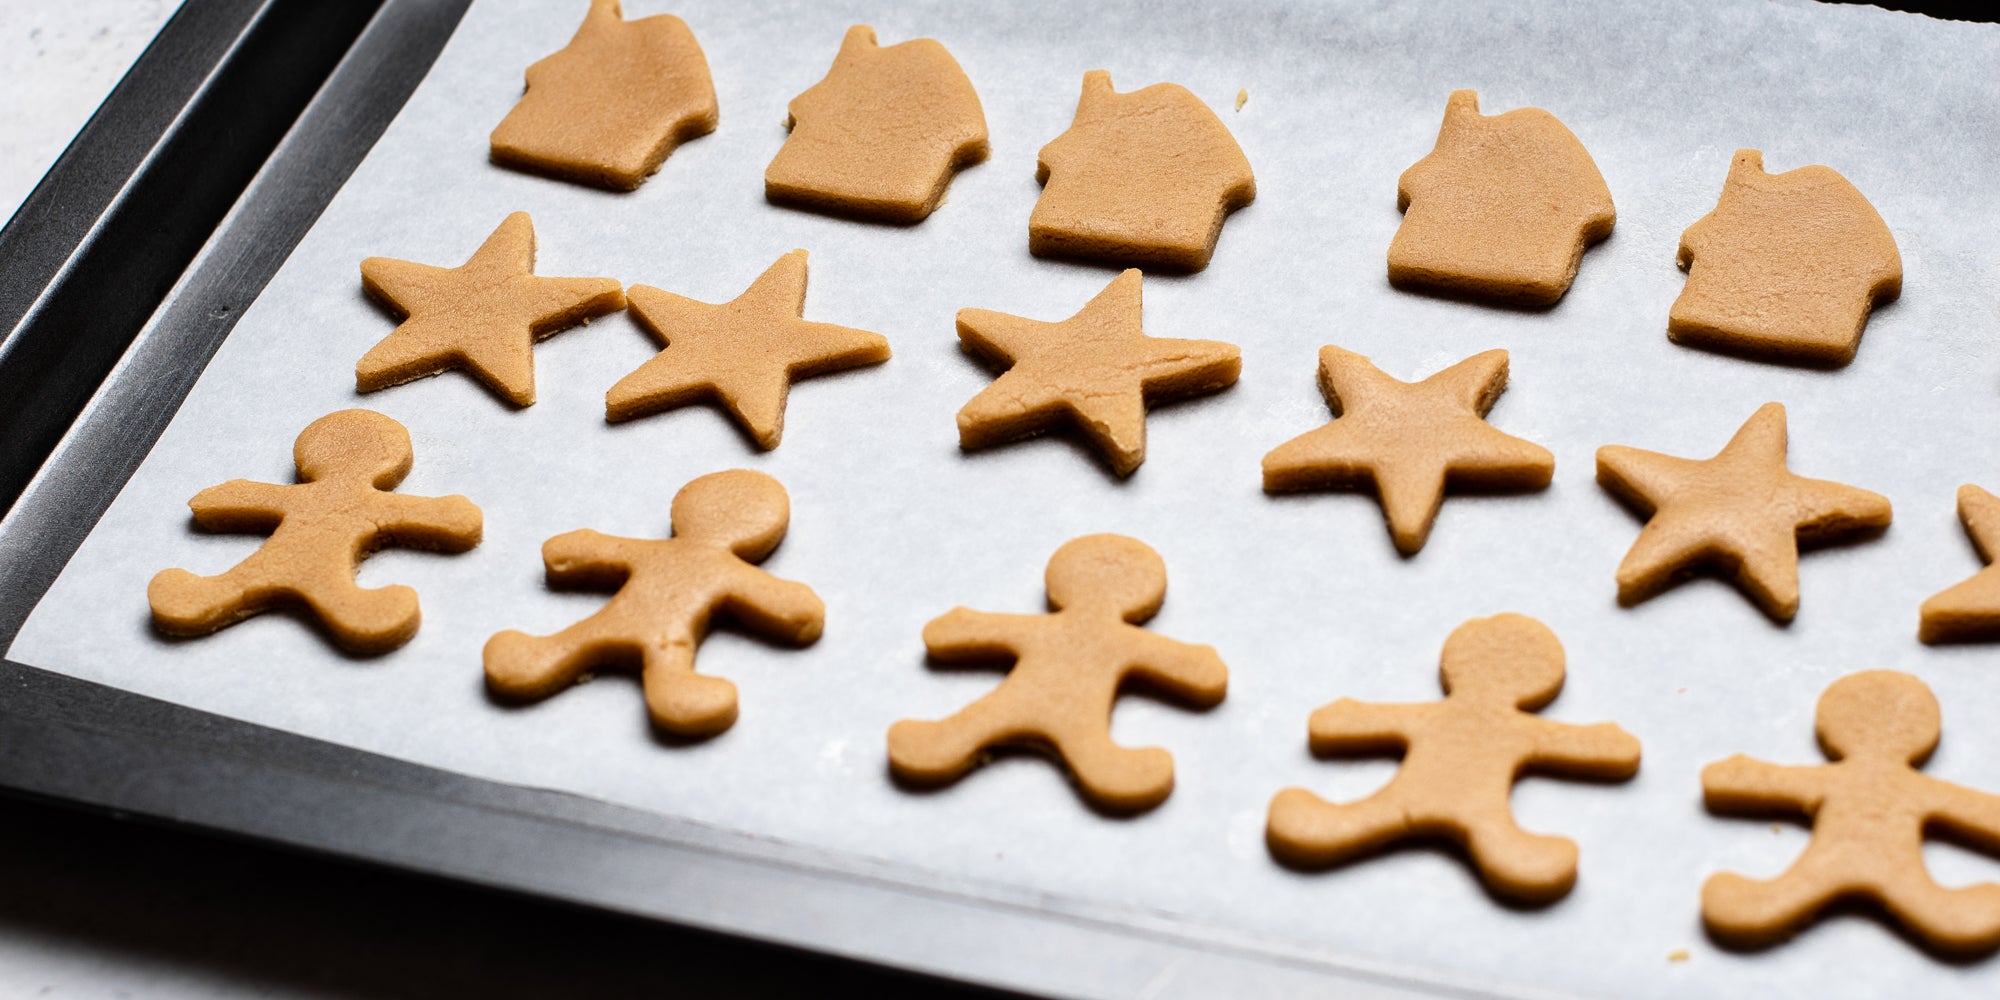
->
1028;70;1256;272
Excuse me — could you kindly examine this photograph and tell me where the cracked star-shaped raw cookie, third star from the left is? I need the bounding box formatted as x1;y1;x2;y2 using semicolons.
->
958;268;1242;476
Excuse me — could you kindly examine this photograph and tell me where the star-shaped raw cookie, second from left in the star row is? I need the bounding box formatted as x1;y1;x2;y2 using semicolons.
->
604;250;888;450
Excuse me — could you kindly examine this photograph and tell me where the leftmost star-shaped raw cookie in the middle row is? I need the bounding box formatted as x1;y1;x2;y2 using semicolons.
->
354;212;624;406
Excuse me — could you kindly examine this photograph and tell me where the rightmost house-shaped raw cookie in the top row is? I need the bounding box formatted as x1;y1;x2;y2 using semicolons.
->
1666;150;1902;366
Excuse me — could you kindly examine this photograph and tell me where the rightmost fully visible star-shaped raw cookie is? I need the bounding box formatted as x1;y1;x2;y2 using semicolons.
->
1598;402;1890;622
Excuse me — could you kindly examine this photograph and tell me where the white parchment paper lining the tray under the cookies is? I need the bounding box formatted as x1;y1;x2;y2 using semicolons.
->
10;0;2000;996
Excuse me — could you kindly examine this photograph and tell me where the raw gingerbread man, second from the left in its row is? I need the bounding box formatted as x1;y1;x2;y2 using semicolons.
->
486;468;826;738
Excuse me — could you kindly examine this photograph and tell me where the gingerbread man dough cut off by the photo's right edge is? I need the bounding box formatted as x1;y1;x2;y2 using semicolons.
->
1702;670;2000;954
